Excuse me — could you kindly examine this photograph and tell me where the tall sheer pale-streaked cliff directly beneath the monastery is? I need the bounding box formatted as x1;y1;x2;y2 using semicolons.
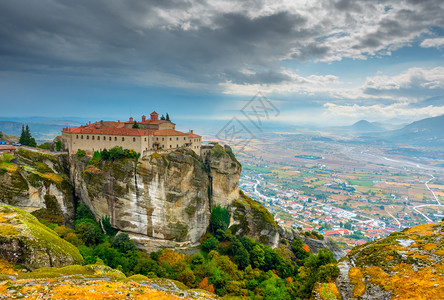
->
70;146;241;251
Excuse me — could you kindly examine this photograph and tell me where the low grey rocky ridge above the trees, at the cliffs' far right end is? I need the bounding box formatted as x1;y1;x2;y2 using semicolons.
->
279;226;347;259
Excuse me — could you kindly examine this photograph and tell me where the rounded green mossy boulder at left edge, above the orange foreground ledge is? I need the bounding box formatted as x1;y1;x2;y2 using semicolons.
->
0;206;83;270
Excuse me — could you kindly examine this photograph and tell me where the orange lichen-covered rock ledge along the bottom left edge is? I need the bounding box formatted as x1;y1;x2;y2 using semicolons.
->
0;261;217;300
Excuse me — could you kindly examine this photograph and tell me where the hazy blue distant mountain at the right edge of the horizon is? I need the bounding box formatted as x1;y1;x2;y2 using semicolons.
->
381;115;444;146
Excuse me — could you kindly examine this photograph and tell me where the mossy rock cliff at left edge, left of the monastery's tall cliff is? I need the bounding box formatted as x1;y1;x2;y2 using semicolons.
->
0;148;75;224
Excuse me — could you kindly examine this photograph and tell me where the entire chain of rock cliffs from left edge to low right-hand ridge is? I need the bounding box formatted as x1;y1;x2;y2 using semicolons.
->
0;145;345;258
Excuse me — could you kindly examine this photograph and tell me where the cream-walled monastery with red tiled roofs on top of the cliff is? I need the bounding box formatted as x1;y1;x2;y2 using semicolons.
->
62;111;202;155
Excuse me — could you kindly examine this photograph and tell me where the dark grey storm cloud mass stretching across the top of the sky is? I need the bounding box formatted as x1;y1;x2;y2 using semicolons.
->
0;0;444;89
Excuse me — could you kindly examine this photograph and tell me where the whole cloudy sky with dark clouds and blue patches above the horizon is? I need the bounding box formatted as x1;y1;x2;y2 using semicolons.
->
0;0;444;125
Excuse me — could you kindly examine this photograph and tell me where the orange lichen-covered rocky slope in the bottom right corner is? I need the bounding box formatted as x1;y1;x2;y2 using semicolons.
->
318;222;444;299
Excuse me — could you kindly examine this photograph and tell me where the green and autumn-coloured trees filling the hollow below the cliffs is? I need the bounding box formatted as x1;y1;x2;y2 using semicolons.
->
36;204;338;299
